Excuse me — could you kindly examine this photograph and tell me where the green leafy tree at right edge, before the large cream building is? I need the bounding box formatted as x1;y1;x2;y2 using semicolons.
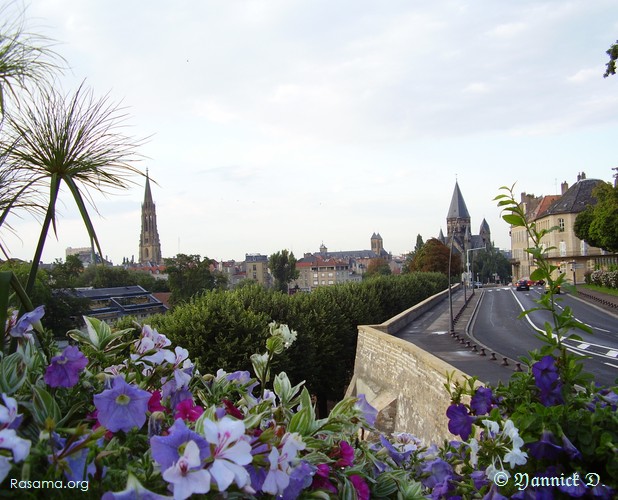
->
573;182;618;252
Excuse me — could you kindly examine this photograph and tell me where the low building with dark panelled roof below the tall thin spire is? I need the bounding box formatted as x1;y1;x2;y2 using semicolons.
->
72;286;168;325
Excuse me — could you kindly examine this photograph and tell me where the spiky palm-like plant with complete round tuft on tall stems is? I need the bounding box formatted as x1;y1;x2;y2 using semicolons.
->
0;84;143;293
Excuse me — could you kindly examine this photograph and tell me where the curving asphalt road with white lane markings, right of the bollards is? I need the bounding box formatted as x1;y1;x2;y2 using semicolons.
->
469;287;618;385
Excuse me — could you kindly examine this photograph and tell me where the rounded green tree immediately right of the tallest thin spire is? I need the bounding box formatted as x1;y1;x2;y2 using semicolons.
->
165;253;227;305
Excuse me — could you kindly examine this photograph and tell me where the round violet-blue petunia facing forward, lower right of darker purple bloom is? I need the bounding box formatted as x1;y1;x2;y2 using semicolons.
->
94;377;151;432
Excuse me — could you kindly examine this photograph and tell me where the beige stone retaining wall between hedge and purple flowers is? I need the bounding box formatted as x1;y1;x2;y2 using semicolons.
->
347;298;472;443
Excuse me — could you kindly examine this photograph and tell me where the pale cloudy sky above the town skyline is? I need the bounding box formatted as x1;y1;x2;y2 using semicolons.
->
5;0;618;264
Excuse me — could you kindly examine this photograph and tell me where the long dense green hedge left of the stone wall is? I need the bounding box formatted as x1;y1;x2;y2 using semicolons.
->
150;273;447;414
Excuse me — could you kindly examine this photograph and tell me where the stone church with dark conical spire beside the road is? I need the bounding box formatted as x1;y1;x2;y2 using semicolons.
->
438;181;491;269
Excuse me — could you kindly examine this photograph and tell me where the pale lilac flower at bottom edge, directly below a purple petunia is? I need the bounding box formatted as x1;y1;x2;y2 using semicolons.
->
163;441;210;500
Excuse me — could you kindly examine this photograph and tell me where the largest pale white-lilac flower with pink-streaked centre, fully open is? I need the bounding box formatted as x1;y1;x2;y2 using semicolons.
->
204;417;253;491
